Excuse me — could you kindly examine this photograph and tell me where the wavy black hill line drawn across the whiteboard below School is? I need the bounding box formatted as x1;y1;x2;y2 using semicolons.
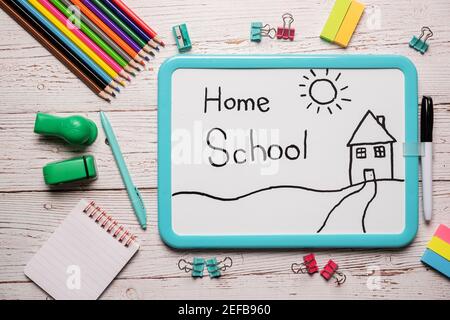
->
172;179;405;201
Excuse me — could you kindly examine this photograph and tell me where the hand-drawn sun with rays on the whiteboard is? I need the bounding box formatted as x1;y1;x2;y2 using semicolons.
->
299;69;352;114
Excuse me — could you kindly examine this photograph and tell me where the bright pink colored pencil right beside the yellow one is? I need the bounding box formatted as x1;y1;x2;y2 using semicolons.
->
37;0;131;80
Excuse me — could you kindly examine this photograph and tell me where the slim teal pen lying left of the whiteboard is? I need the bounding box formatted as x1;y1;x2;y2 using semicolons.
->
100;111;147;230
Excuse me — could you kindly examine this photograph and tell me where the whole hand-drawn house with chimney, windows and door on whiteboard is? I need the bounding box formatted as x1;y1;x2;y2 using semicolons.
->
347;110;397;185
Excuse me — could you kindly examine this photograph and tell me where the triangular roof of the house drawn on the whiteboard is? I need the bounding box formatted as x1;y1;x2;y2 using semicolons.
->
347;110;397;147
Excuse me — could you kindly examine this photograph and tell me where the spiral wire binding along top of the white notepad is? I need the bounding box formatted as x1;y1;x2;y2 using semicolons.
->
83;201;136;247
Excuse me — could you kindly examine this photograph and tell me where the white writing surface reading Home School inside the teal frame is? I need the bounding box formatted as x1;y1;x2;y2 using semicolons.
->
160;55;417;249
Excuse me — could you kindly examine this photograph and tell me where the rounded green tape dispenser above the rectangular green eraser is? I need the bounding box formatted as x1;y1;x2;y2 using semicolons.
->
34;112;98;146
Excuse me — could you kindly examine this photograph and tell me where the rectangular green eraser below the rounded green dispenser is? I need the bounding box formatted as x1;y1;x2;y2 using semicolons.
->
43;155;97;185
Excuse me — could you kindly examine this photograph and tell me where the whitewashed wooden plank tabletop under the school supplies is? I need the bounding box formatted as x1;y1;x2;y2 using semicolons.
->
0;0;450;299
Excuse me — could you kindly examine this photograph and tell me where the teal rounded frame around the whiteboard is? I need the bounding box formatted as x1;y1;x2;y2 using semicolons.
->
158;55;419;249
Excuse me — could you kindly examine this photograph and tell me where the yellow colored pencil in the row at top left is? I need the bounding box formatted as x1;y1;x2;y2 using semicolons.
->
28;0;125;85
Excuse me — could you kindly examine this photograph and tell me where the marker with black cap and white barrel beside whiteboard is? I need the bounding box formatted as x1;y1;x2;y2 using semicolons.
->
420;96;434;222
